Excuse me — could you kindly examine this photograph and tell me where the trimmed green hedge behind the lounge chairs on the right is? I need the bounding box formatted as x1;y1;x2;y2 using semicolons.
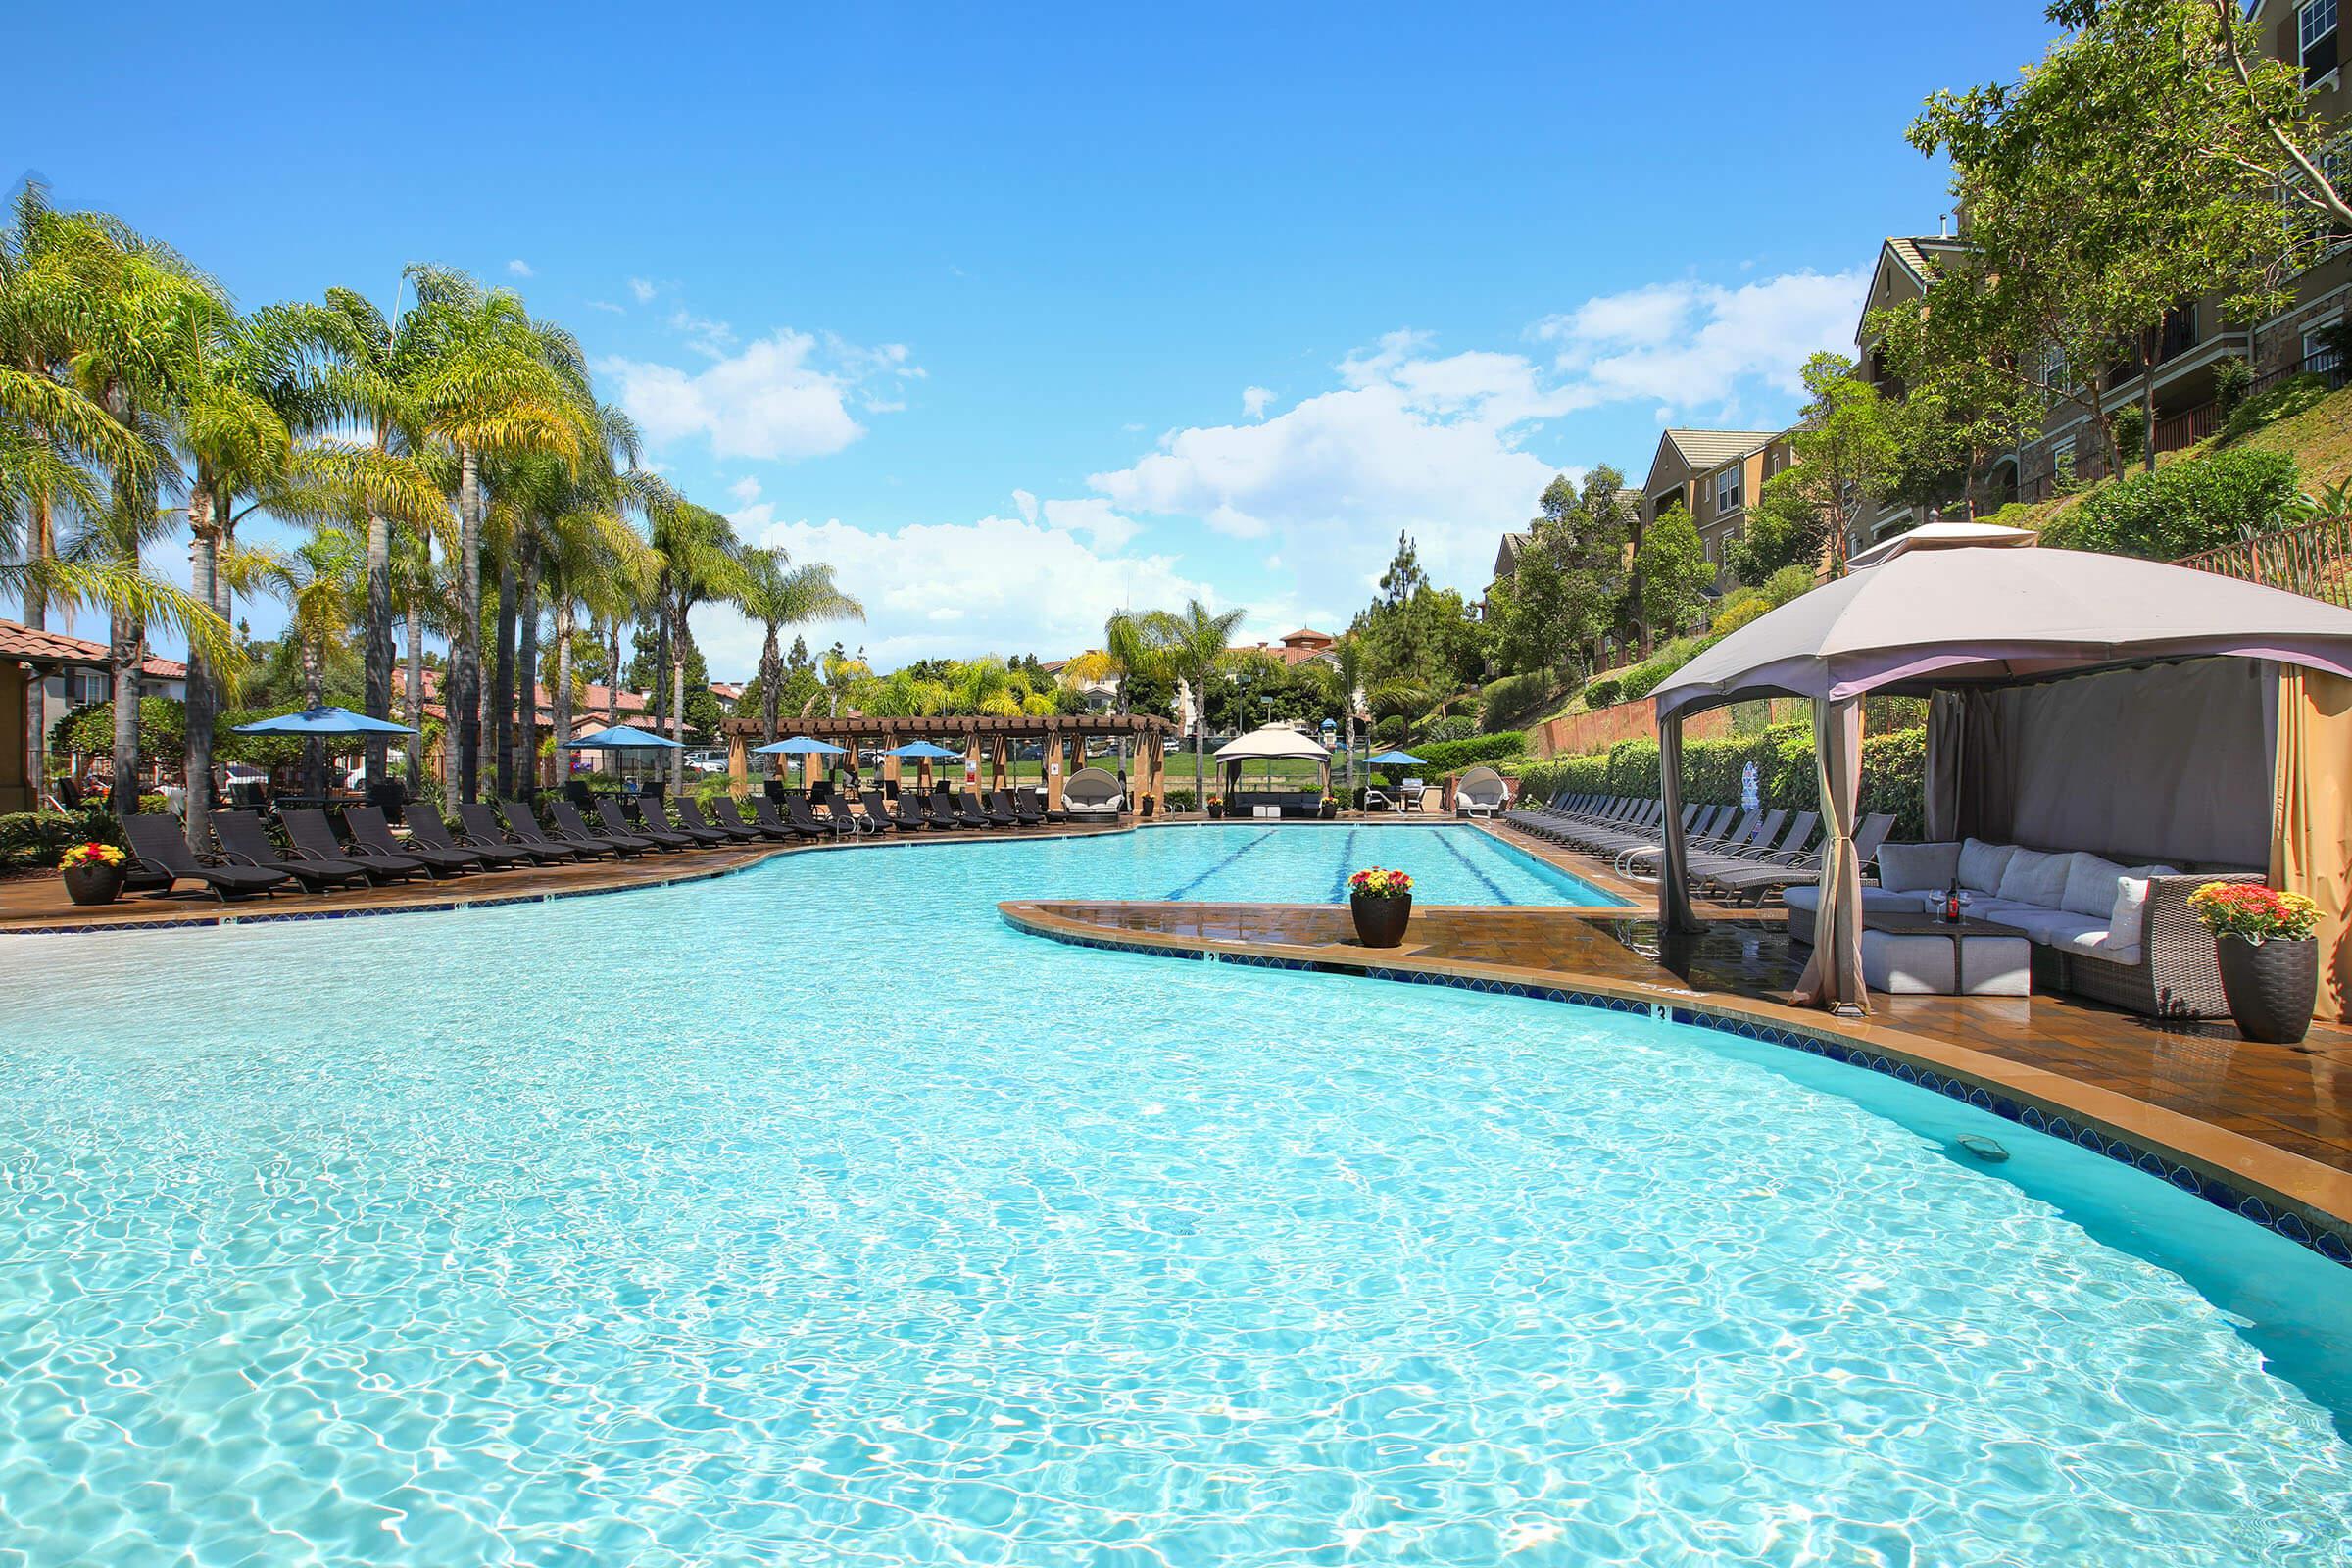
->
1519;724;1927;839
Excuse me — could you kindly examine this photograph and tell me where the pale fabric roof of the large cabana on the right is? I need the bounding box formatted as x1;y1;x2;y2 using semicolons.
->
1656;548;2352;719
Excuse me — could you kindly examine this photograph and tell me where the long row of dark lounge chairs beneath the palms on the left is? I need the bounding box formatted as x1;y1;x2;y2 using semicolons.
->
112;790;1070;901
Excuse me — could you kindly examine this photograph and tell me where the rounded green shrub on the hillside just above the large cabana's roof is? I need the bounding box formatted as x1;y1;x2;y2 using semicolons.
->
2041;449;2295;562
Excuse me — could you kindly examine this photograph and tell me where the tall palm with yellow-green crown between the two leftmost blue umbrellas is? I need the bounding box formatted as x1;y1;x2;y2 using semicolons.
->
405;266;595;804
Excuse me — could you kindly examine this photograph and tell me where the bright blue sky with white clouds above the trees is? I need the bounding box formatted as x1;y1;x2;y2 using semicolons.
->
0;0;2048;674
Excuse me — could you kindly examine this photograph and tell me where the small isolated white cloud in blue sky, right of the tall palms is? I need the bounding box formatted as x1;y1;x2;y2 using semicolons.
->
598;329;919;459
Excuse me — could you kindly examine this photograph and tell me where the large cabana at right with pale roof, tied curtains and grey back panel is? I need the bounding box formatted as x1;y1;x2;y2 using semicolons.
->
1656;540;2352;1010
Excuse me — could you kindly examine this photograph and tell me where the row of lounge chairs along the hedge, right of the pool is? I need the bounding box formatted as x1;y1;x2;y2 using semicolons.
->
1503;795;1895;903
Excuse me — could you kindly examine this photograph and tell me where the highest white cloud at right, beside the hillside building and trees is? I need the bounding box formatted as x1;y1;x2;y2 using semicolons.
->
1536;270;1870;416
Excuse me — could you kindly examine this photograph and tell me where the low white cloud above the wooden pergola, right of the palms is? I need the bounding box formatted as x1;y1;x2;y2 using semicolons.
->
694;501;1213;679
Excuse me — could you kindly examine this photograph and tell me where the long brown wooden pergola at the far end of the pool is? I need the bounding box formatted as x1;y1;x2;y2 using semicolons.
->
719;712;1176;813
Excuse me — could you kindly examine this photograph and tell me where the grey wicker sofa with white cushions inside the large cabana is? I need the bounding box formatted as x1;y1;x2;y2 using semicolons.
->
1788;839;2263;1018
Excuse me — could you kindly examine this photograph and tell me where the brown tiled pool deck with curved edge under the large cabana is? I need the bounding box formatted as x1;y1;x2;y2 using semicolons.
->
1000;825;2352;1255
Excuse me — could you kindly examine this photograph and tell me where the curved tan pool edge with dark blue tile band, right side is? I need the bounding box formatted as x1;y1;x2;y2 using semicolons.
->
998;898;2352;1267
